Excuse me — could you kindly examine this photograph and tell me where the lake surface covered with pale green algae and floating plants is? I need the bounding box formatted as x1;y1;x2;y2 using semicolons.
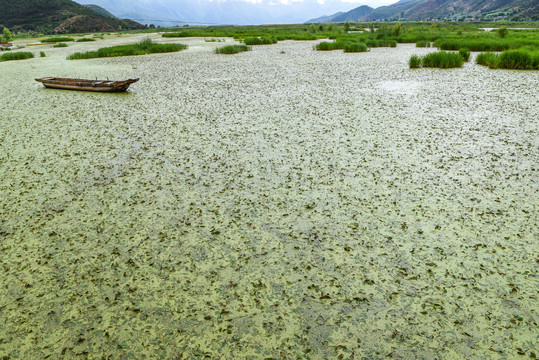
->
0;35;539;359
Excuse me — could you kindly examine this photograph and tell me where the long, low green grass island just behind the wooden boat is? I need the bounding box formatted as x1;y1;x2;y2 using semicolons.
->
67;38;187;60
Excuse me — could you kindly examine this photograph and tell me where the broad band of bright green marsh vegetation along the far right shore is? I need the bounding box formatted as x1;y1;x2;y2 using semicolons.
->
162;22;539;58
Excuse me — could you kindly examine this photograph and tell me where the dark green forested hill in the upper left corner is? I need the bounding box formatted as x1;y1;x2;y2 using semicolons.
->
0;0;144;33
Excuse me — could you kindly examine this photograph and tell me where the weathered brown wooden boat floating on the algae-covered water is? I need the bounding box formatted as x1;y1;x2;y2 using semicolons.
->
36;77;139;92
